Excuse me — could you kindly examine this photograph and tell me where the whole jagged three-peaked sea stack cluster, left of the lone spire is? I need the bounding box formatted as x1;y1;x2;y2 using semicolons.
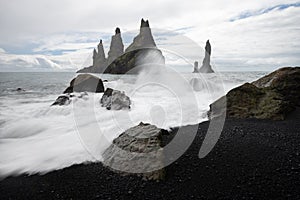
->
77;19;165;74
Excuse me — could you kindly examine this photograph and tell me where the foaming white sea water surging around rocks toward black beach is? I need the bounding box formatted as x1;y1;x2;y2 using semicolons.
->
0;69;267;178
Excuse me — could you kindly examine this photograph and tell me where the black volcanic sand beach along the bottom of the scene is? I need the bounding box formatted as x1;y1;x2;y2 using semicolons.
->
0;109;300;200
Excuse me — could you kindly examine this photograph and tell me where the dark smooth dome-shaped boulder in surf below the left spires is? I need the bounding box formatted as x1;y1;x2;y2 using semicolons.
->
64;74;104;93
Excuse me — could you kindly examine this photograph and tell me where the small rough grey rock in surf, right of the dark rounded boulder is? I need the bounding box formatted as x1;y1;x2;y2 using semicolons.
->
100;88;131;110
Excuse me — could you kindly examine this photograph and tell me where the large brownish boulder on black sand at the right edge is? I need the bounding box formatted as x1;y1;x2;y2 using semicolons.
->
208;67;300;120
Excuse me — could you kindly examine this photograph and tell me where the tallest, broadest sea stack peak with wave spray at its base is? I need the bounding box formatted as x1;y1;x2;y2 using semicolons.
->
104;19;165;74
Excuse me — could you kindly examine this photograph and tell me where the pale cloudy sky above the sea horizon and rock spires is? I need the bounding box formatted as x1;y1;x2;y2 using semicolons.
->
0;0;300;71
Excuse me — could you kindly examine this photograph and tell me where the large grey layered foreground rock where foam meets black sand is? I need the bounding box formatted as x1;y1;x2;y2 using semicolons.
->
103;122;167;181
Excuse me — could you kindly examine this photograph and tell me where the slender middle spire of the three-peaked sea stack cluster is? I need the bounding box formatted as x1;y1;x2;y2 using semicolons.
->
107;27;124;65
